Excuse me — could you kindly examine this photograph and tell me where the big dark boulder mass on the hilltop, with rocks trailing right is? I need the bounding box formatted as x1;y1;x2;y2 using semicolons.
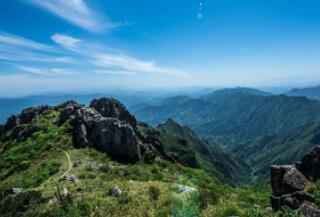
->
58;98;173;163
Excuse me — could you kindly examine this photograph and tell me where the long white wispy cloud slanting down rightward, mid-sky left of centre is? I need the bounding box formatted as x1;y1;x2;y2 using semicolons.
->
51;34;186;75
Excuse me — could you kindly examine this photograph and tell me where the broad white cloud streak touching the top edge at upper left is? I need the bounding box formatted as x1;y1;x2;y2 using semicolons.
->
30;0;117;32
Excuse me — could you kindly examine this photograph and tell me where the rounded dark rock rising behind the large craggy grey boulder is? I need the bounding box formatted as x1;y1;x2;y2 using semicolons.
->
90;98;137;130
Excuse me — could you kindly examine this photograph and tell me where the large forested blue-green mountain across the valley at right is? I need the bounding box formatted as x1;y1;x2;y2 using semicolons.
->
134;89;320;181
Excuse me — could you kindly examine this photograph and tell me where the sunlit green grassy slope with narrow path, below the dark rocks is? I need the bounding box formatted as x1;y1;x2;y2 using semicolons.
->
0;107;276;217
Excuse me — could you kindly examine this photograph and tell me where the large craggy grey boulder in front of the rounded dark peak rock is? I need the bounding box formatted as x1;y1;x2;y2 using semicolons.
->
59;102;142;163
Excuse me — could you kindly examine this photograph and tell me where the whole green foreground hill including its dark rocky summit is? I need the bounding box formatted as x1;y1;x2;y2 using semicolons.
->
0;99;271;217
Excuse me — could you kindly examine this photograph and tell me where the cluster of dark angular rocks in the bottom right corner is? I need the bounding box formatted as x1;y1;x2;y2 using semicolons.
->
271;146;320;217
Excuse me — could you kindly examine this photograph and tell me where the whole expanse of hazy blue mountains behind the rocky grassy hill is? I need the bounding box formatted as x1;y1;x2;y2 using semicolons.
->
0;84;320;183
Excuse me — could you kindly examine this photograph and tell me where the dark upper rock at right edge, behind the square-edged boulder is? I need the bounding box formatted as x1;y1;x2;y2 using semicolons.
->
296;146;320;181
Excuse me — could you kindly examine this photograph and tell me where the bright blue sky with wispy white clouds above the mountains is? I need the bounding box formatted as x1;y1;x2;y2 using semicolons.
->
0;0;320;96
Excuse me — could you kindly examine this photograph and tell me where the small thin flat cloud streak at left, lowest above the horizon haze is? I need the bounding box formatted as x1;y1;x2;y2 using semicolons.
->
17;66;76;76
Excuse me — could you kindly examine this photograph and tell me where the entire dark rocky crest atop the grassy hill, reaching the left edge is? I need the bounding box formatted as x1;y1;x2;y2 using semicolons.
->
0;98;174;163
